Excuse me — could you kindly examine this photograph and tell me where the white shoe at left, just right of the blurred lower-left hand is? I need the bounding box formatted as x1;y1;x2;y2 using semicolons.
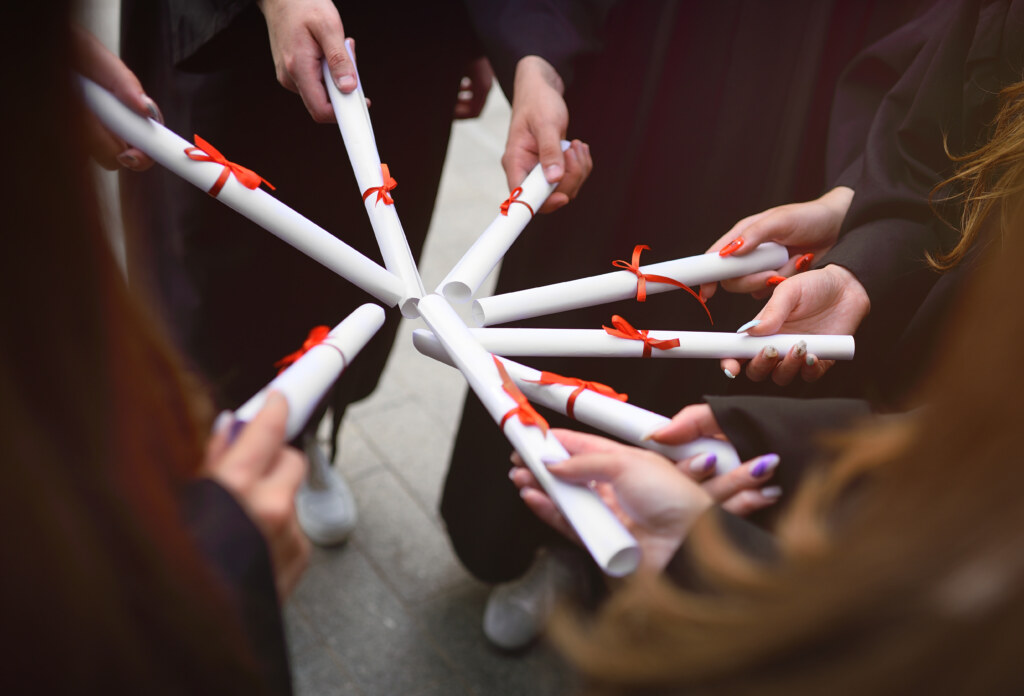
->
295;435;357;547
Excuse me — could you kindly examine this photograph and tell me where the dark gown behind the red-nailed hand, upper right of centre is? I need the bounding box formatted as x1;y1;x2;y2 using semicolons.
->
441;0;915;581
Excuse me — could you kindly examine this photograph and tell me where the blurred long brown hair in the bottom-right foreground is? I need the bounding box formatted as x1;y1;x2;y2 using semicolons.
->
555;95;1024;695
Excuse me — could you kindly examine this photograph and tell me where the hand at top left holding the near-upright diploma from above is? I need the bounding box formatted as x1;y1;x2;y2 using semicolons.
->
257;0;356;123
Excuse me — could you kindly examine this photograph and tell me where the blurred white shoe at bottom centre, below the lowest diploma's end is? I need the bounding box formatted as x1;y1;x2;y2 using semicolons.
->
483;549;586;650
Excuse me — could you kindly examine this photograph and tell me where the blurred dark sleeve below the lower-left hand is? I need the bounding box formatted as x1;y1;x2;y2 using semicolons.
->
180;478;292;694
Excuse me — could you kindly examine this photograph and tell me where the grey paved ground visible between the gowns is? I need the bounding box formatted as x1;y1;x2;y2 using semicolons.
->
81;0;572;696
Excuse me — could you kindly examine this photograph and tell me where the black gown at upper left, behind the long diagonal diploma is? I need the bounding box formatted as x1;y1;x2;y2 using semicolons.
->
121;0;475;416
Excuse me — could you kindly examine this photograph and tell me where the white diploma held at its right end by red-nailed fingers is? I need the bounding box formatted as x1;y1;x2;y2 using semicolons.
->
473;242;790;327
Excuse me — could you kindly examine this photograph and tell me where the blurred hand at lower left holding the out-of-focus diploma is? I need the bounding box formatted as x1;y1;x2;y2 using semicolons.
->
205;392;309;597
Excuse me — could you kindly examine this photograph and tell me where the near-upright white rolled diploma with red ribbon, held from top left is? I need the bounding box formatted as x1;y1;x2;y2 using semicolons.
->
323;52;424;317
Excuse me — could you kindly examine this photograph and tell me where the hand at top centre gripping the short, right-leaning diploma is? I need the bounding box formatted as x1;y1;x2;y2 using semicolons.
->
502;55;594;213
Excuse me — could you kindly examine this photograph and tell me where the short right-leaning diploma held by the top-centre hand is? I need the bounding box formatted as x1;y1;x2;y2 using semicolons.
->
434;140;569;302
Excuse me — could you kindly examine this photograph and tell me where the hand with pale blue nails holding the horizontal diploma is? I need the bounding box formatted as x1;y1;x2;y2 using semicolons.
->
721;264;871;385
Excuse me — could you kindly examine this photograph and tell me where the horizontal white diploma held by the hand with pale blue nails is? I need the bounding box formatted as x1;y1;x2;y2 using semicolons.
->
452;329;854;360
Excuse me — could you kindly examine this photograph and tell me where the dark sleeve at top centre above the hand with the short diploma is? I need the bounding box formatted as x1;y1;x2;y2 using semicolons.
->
465;0;614;101
